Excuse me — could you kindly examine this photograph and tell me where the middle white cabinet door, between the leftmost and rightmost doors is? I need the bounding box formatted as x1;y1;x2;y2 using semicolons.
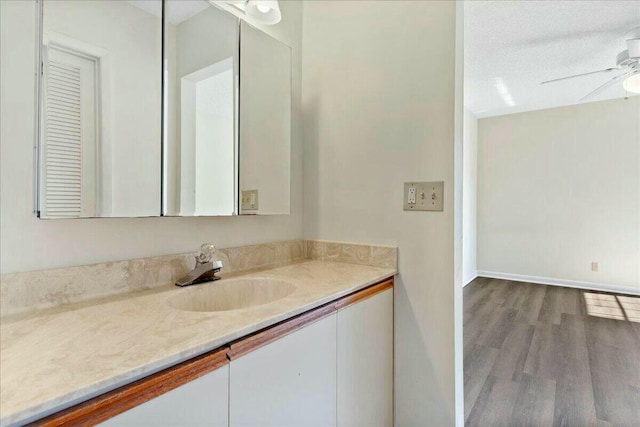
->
229;313;336;427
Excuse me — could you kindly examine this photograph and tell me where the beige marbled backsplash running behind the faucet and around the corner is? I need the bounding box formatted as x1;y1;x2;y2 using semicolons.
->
0;239;397;316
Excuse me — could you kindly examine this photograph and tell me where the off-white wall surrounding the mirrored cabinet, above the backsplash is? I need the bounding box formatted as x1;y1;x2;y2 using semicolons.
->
0;0;303;274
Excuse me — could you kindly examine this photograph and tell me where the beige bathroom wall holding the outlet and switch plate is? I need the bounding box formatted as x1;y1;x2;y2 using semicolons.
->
303;1;456;426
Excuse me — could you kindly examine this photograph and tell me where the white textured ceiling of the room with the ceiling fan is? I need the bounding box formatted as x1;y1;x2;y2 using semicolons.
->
464;0;640;118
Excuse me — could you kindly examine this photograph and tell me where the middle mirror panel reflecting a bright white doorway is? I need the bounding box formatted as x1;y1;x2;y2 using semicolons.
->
163;0;238;216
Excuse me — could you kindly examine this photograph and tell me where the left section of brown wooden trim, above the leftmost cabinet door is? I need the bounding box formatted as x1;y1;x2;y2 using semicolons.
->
29;347;229;427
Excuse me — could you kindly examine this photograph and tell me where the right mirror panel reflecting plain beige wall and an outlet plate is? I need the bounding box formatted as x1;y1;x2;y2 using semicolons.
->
240;21;291;215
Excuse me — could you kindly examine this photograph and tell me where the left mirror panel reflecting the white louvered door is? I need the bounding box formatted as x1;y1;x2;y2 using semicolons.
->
38;0;162;218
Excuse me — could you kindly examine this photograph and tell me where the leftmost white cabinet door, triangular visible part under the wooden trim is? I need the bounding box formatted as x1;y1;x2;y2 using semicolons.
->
100;365;229;427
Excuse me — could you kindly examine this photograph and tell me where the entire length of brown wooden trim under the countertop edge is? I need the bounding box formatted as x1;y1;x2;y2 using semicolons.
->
28;277;394;427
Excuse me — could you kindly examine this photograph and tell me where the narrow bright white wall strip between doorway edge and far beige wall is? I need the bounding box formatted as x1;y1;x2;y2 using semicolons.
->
462;109;478;285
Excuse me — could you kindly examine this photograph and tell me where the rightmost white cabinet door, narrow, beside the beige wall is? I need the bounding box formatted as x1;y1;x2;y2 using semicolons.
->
337;289;393;427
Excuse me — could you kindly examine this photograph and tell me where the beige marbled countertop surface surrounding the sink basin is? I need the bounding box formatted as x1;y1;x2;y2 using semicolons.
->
0;260;396;426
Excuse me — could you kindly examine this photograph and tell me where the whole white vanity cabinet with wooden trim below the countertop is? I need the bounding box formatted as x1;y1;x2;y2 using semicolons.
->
34;278;393;427
